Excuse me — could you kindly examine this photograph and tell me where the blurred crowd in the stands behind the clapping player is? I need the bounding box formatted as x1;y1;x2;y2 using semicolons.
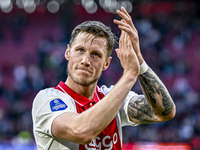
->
0;0;200;149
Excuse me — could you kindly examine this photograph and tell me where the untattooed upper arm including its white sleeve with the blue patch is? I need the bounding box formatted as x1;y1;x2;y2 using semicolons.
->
32;89;86;141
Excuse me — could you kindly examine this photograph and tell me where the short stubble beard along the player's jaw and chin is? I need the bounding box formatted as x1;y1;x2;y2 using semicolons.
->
67;66;101;87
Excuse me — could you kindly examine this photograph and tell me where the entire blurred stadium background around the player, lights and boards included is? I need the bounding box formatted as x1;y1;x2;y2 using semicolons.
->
0;0;200;150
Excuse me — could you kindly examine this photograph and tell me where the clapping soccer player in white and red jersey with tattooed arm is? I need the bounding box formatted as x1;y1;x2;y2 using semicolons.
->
32;7;175;150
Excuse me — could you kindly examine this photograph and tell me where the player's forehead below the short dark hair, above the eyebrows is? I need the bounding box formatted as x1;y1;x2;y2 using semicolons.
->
72;32;107;49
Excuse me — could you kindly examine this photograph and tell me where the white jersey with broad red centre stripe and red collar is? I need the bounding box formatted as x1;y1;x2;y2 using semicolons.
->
32;81;137;150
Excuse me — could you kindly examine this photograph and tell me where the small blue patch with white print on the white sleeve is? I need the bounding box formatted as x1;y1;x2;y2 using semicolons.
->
50;99;68;112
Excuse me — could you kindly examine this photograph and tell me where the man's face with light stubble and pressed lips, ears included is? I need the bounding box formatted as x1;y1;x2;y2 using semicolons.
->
65;33;111;86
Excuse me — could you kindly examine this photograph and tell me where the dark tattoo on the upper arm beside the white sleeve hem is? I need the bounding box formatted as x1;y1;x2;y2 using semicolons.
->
128;95;156;123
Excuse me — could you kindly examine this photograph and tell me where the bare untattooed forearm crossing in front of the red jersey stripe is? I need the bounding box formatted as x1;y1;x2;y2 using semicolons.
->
80;75;137;138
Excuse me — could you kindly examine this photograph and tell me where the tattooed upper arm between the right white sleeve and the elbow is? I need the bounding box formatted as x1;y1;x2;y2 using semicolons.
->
127;95;162;124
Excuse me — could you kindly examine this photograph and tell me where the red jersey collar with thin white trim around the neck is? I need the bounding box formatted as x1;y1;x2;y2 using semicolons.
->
56;81;99;106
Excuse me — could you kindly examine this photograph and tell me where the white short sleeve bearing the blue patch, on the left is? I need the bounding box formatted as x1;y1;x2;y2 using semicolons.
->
32;88;76;137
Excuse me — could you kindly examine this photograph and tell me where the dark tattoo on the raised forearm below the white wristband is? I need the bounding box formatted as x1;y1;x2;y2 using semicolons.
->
139;68;173;116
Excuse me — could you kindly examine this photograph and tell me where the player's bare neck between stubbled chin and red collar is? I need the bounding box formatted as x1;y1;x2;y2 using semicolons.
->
65;77;97;100
